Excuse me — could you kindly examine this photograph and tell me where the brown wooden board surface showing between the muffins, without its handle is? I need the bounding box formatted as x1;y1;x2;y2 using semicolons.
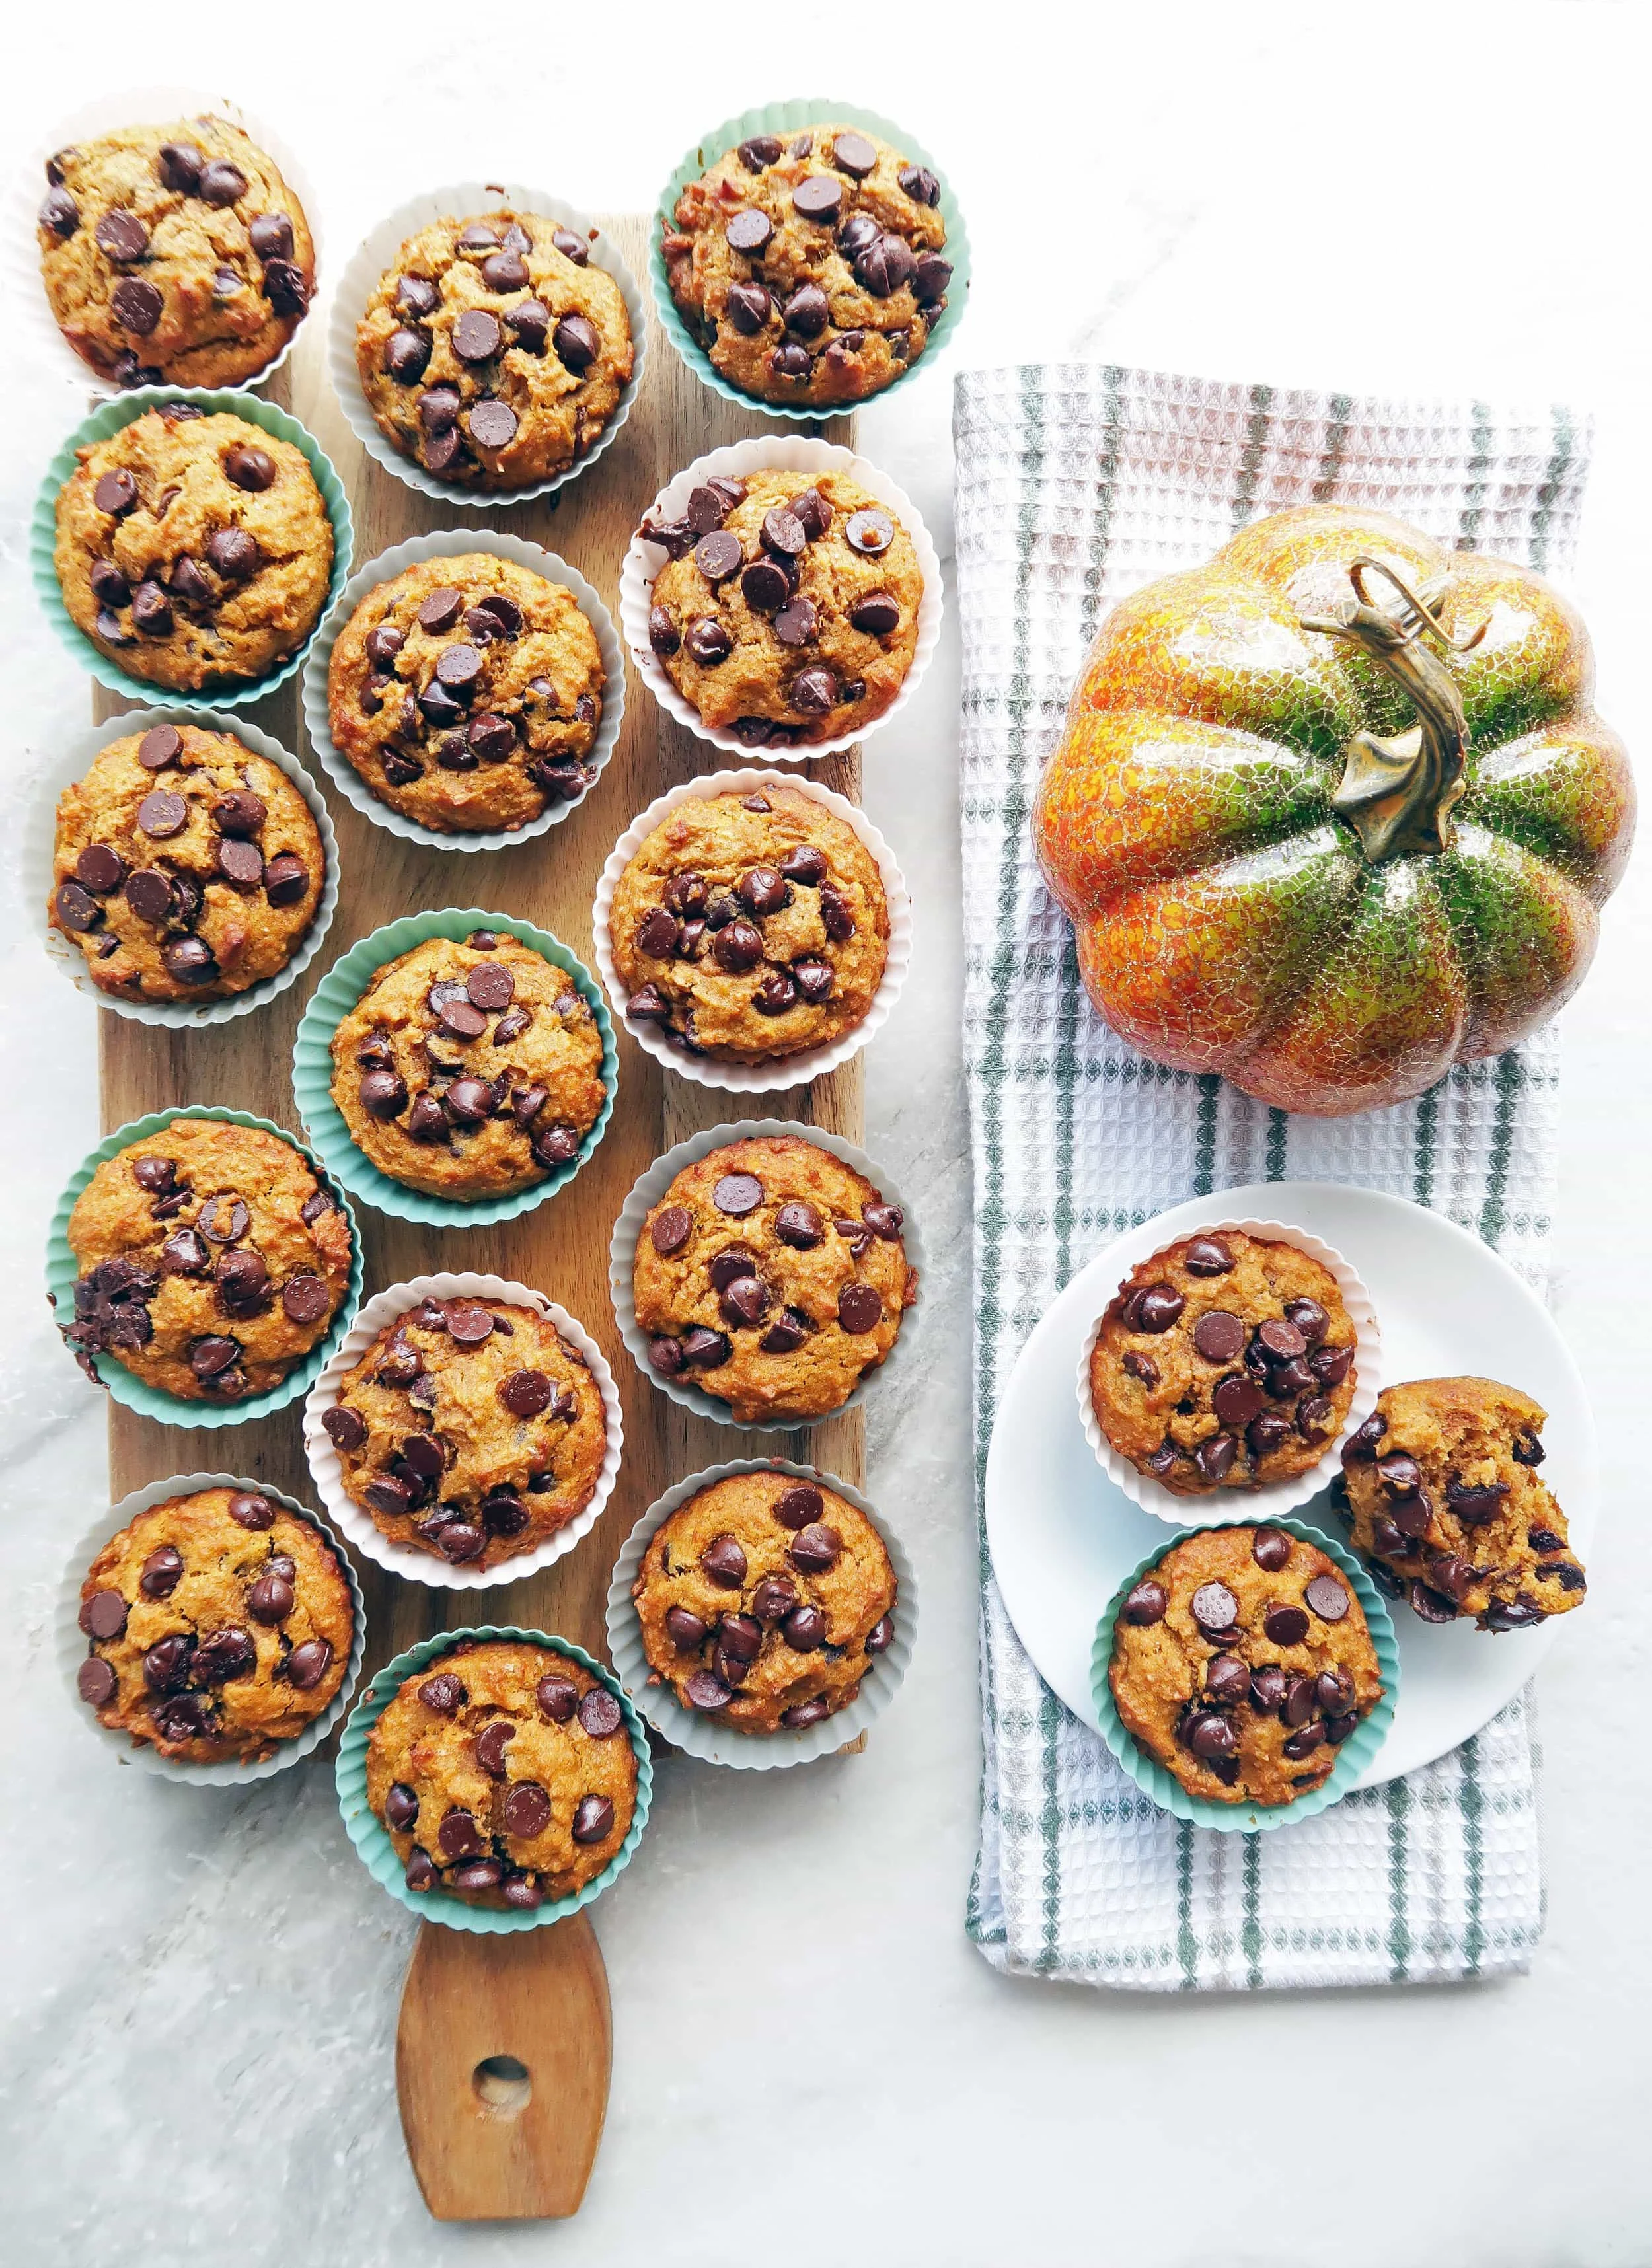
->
98;215;864;1687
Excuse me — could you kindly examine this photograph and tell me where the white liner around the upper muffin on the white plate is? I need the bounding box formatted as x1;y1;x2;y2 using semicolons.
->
1078;1220;1382;1529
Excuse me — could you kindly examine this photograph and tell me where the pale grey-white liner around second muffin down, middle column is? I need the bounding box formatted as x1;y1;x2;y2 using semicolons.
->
299;529;626;850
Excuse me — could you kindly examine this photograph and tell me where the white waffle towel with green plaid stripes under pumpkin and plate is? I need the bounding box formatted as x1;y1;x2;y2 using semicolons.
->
953;365;1589;1991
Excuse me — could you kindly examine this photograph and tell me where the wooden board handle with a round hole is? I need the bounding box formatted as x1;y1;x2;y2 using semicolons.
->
395;1914;613;2220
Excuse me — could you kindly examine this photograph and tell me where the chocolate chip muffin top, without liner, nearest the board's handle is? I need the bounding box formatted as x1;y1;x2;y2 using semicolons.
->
367;1638;638;1907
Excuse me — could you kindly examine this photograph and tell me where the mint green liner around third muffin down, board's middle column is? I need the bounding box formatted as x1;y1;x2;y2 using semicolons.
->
293;905;620;1229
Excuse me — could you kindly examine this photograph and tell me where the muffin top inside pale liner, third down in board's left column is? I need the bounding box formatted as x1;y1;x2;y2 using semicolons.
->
48;723;327;1000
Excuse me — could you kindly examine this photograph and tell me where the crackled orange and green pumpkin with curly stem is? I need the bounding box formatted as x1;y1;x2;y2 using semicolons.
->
1035;503;1634;1116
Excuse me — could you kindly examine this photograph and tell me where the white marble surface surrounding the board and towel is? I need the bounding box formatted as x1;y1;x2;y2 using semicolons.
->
0;0;1652;2268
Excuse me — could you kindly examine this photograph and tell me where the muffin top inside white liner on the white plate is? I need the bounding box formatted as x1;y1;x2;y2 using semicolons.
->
1089;1229;1359;1497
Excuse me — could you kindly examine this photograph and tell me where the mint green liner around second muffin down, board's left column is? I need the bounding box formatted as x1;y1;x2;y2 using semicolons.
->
30;386;354;710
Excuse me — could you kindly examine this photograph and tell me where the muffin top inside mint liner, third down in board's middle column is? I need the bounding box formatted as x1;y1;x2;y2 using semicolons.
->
331;930;603;1200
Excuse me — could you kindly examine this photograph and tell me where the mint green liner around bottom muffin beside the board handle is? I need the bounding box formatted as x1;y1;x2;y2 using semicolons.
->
334;1624;654;1937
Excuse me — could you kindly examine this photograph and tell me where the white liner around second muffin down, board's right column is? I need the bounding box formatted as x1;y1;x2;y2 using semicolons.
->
620;437;942;764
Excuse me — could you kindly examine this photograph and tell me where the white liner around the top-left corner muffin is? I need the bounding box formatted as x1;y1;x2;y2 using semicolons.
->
11;86;322;402
